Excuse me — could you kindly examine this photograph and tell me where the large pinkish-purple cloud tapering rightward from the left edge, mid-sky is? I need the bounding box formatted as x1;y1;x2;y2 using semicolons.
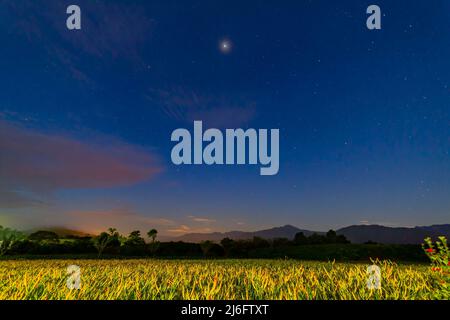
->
0;120;161;207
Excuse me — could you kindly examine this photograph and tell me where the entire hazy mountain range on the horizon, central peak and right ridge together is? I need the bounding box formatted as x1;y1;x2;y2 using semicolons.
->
171;224;450;244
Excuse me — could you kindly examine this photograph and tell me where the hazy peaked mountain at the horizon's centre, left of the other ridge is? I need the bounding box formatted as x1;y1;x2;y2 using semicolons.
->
172;225;322;243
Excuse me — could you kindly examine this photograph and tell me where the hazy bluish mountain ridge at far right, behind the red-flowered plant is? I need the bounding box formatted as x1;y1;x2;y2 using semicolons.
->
336;224;450;244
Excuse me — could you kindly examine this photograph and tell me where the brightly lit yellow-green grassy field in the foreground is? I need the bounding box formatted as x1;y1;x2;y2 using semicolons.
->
0;260;449;300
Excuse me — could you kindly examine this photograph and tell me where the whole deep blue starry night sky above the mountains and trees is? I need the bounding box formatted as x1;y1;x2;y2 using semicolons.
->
0;0;450;235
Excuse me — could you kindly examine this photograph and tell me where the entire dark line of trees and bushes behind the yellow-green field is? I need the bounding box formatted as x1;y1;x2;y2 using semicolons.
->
0;226;426;261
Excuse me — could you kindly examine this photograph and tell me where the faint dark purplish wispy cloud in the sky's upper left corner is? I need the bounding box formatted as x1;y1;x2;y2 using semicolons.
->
4;0;154;83
